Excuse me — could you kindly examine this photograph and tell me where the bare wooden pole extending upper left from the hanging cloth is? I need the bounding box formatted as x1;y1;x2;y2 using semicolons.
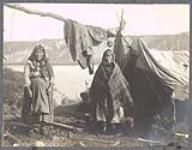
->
5;4;66;22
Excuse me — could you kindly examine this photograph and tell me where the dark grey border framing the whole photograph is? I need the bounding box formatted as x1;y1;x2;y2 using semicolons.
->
0;0;192;150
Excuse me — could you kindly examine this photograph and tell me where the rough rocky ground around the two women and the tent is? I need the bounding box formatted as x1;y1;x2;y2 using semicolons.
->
3;68;188;147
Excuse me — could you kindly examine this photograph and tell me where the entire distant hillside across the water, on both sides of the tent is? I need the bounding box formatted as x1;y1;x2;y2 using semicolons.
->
4;32;189;65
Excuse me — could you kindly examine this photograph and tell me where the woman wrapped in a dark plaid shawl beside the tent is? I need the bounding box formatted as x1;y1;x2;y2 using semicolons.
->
90;49;133;131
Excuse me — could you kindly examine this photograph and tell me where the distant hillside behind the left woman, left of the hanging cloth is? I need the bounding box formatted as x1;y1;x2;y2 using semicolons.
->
4;39;74;64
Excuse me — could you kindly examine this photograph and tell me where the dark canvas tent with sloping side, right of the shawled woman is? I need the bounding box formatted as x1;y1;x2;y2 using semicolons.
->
114;31;187;120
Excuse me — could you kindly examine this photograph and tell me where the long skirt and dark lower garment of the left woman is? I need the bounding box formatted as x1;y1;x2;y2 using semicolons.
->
22;78;54;123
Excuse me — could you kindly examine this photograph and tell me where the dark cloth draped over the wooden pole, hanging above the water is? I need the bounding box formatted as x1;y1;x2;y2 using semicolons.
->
64;19;114;74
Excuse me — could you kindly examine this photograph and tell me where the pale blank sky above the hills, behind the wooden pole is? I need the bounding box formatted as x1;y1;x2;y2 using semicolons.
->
4;3;190;41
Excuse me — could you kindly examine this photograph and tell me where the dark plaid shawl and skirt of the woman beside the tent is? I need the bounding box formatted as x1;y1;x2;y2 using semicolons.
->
90;62;133;121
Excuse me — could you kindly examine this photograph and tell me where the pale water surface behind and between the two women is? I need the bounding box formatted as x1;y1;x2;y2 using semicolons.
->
5;65;96;99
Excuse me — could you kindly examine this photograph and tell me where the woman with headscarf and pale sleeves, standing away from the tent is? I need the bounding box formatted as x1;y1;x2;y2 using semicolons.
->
23;45;54;121
